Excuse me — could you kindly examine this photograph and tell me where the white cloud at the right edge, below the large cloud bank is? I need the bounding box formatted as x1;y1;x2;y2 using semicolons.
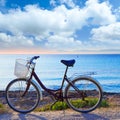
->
91;22;120;43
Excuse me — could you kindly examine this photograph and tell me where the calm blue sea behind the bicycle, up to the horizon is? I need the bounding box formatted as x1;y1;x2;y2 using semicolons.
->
0;54;120;93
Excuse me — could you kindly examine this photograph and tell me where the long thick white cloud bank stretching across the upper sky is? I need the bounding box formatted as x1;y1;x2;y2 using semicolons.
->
0;0;115;35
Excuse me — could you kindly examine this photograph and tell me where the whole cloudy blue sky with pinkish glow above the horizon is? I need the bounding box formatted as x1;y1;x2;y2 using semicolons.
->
0;0;120;54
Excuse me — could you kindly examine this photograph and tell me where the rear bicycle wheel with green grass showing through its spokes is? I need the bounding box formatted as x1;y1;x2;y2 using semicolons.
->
65;77;102;113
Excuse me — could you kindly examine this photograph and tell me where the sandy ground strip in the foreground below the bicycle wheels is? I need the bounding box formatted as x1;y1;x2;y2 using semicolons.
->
0;108;120;120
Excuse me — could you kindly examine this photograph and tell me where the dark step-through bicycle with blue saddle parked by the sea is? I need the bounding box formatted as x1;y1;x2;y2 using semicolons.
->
6;56;102;113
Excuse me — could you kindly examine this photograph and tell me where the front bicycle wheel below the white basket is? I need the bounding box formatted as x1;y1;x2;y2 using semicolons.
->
6;79;40;113
